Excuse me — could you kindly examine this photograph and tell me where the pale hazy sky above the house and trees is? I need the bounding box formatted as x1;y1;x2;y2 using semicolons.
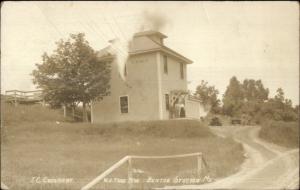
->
1;2;299;104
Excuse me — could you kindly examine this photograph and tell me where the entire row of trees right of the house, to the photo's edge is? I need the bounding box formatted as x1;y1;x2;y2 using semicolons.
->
194;76;299;124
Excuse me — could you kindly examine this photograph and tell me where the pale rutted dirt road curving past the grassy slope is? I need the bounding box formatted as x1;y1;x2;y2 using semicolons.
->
162;126;299;189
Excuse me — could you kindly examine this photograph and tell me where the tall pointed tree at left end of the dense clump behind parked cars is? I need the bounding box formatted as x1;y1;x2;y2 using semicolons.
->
223;76;244;116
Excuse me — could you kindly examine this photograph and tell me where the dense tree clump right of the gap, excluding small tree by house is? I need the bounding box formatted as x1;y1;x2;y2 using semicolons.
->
223;77;298;123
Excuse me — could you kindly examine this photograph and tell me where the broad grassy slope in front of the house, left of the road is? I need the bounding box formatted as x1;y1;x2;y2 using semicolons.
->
1;106;243;189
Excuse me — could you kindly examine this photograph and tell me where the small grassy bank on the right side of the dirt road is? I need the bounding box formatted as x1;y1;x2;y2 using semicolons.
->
259;121;299;148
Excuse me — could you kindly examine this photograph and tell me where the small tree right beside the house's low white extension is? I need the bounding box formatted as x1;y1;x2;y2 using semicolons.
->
194;80;220;113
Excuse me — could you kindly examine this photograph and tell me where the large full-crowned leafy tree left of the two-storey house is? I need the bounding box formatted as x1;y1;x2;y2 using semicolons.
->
32;33;110;121
